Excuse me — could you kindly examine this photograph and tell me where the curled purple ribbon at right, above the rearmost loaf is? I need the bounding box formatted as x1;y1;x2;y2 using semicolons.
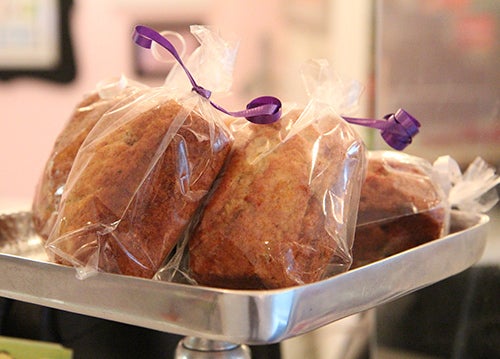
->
342;108;420;151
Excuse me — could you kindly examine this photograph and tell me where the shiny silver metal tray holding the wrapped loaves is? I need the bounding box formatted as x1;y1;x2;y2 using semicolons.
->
0;212;489;344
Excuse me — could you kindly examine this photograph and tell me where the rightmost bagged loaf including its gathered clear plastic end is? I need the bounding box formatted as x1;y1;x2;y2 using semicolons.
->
352;151;500;268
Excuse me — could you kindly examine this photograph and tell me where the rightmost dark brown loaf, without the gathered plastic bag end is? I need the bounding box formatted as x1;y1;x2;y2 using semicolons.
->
352;151;449;268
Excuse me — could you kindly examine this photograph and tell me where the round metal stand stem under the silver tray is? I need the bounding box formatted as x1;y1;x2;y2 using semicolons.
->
175;337;252;359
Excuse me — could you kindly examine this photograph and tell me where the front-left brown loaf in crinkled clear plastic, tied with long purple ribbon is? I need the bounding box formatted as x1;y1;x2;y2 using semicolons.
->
46;28;232;278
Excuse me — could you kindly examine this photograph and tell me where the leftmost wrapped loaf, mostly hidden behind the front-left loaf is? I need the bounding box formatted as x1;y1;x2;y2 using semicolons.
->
32;78;141;240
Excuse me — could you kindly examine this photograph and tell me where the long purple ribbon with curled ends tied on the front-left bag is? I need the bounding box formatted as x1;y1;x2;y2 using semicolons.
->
133;25;281;124
